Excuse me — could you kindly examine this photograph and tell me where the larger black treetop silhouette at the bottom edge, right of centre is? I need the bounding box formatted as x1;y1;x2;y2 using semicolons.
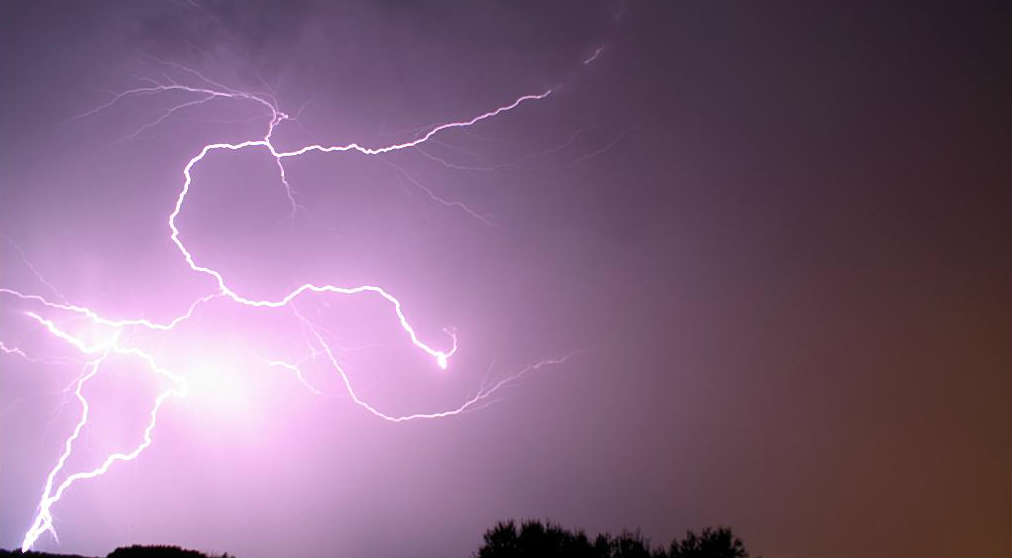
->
476;520;748;558
